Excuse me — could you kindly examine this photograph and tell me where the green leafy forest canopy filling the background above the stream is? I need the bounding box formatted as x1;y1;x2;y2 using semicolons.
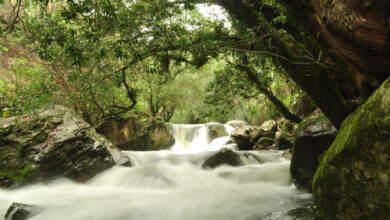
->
0;0;336;126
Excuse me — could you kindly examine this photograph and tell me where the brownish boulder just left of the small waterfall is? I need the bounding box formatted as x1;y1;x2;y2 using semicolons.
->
97;118;175;151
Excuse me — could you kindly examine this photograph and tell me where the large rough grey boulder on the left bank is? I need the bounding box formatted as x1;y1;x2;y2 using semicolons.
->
0;106;126;188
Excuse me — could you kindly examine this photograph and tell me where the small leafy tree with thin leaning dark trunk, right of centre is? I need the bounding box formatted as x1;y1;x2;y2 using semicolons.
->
207;54;301;123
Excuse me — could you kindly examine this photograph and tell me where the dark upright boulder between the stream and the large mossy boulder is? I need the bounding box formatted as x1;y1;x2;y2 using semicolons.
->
290;112;337;191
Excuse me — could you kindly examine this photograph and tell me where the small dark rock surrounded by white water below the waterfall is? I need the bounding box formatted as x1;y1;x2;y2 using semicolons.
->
202;149;243;169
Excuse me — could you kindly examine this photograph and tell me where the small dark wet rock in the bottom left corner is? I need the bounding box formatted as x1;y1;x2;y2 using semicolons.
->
4;202;42;220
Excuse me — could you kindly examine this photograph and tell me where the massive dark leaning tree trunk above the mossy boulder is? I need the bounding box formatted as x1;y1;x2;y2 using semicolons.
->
203;0;390;127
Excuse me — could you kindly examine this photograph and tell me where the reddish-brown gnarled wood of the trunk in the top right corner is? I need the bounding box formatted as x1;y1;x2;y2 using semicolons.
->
314;0;390;82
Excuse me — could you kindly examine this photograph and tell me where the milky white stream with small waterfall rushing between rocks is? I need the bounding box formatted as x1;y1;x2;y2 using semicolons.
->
0;125;311;220
